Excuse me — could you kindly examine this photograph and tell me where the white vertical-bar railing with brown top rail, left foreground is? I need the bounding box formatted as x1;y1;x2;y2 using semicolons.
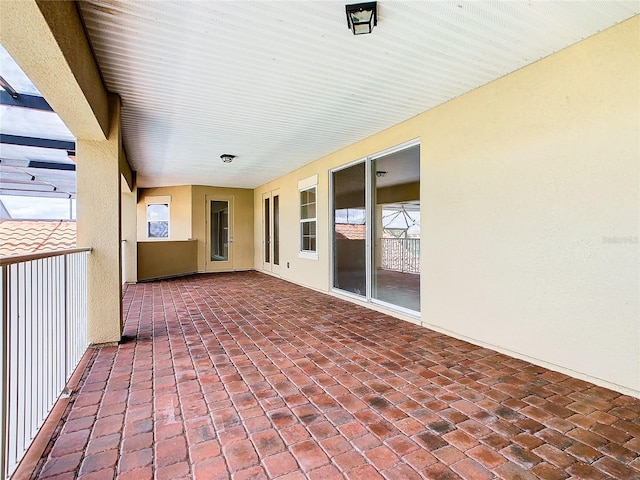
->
0;248;91;479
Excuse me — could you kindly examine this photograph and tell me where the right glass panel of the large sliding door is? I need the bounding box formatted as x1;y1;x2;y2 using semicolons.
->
371;146;420;311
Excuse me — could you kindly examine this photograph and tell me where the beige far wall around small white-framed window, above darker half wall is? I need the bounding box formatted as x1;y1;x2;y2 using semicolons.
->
137;185;192;242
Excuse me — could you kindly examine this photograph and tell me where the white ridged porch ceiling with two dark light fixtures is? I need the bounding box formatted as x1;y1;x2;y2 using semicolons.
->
79;0;640;188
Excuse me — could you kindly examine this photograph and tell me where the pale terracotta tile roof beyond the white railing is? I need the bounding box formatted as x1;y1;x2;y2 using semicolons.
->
0;220;76;257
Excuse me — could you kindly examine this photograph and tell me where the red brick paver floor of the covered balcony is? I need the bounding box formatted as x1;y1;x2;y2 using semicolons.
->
36;272;640;480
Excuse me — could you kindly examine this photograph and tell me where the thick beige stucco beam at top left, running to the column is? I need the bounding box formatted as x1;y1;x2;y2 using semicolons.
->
0;0;110;140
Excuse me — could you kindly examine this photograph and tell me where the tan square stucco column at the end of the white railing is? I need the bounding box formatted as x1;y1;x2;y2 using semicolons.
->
76;94;123;345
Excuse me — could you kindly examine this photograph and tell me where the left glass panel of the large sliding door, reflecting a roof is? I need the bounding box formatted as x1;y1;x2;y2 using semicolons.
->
332;162;367;296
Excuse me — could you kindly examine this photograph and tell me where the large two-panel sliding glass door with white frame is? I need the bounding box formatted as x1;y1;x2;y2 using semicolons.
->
331;144;420;313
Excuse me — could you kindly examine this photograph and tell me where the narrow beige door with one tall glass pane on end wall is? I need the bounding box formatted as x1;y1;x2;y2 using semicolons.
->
205;195;233;272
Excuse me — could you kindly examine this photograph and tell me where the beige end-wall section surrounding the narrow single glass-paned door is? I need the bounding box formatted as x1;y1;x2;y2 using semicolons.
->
192;185;254;272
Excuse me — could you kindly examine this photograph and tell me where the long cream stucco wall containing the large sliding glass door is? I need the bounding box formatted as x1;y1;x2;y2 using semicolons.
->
254;17;640;395
